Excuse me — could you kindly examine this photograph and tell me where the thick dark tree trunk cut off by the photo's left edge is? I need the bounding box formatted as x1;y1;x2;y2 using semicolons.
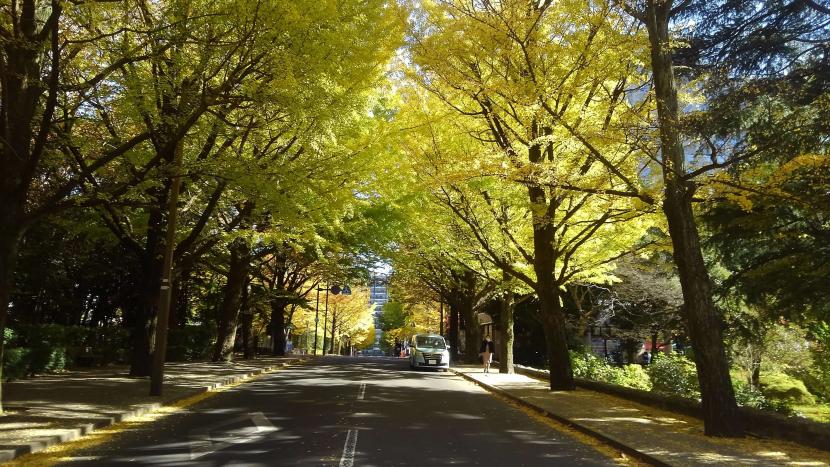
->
0;0;62;413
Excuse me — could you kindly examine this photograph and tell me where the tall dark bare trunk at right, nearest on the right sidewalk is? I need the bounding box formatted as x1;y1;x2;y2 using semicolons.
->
645;0;744;436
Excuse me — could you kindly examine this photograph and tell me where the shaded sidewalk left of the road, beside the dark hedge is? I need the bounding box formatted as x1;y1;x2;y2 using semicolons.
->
0;356;304;462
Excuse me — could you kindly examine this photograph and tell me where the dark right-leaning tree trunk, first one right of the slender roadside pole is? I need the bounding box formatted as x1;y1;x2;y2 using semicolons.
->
213;238;251;362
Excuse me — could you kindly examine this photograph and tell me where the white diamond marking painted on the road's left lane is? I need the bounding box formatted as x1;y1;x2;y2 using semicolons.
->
190;412;279;460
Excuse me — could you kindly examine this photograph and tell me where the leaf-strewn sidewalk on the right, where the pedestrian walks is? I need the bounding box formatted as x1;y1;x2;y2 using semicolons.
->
452;366;830;466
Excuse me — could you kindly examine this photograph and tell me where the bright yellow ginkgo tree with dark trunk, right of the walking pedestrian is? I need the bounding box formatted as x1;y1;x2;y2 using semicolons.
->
409;1;653;389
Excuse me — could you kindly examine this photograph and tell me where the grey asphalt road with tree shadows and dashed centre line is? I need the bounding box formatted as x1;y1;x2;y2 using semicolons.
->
60;357;614;467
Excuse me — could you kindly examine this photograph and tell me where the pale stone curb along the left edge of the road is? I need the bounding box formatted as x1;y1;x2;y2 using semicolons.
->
0;358;305;462
